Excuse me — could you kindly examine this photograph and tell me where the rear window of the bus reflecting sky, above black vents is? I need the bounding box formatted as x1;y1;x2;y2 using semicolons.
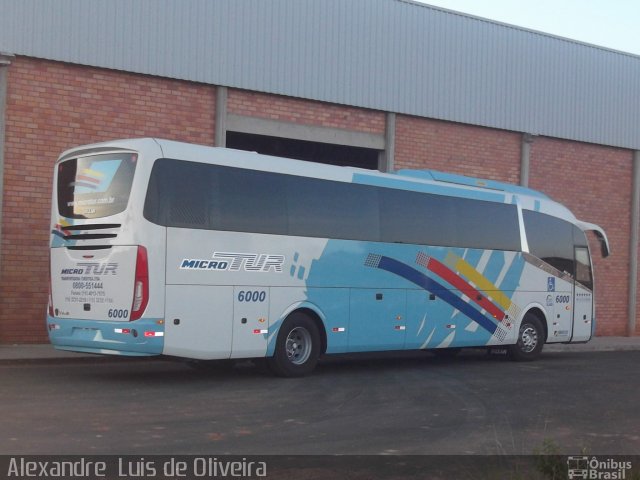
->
58;152;137;219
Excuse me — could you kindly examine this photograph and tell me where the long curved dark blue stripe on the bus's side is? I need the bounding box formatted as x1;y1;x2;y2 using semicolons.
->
367;255;497;335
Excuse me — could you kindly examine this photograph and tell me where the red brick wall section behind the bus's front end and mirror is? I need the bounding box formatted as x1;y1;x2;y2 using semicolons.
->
530;138;633;335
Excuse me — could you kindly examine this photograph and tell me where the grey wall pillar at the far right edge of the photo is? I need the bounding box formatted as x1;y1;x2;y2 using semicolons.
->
627;150;640;337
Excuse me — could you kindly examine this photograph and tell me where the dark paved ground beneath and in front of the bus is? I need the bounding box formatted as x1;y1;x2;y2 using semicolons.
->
0;350;640;456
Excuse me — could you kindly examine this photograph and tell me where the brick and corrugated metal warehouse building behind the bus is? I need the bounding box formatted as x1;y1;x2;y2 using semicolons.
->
0;0;640;344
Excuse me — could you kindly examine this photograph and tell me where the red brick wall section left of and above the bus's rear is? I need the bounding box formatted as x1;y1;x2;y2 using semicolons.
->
0;57;215;343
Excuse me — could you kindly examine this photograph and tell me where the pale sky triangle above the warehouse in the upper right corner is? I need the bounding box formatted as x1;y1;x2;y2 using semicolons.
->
419;0;640;55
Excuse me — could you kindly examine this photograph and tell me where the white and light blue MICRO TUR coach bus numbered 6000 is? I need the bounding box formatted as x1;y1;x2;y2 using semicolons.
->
47;138;609;376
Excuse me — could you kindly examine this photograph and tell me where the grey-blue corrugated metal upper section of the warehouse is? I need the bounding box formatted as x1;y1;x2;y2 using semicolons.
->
0;0;640;149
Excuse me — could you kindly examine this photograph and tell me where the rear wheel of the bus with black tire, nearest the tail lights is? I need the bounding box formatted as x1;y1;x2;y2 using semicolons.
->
268;312;320;377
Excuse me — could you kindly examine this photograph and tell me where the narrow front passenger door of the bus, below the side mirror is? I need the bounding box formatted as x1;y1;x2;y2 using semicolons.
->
571;247;593;342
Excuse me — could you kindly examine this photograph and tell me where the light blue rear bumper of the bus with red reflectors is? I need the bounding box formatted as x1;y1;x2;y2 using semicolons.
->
47;316;164;356
